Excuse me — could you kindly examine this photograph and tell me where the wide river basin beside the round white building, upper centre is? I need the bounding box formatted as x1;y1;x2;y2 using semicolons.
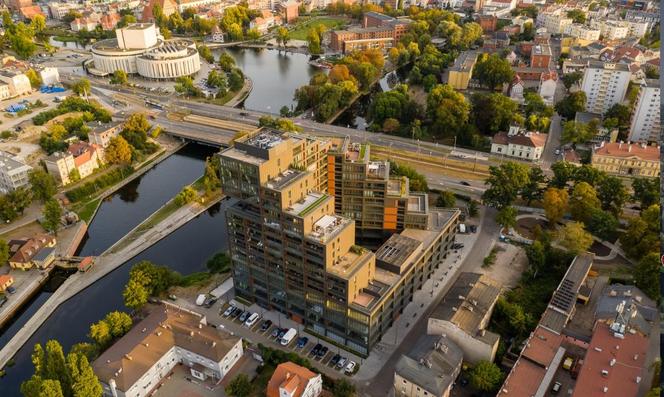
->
220;48;320;114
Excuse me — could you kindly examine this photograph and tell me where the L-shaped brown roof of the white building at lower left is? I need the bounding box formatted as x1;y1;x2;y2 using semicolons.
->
92;305;240;391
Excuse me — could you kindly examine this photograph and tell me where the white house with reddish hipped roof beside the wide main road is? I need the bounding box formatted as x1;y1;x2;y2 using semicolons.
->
491;125;547;161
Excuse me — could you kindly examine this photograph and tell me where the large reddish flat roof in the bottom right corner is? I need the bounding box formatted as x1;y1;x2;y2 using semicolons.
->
572;323;648;397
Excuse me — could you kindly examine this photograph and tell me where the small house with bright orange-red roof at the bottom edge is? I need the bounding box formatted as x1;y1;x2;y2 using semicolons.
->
266;361;323;397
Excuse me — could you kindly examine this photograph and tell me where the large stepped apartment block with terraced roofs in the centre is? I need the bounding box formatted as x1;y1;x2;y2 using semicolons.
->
219;129;459;355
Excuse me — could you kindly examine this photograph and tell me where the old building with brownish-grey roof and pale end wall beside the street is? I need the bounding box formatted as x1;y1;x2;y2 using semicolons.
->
427;273;501;364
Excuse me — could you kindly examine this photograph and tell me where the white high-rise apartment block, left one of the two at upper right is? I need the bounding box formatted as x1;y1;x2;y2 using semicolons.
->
581;61;631;114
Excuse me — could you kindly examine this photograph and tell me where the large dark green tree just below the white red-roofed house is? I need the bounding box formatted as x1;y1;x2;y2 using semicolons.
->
482;161;529;209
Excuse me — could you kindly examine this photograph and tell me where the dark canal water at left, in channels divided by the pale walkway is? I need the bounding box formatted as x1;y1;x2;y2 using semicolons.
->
0;144;228;397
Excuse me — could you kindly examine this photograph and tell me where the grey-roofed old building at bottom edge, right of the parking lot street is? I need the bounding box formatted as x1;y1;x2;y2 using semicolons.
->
394;335;463;397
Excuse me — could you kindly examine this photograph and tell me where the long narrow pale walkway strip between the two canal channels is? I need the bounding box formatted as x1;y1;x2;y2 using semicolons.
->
0;197;221;368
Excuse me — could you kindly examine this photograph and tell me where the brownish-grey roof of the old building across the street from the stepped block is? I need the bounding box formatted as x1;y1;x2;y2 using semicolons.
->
431;272;500;337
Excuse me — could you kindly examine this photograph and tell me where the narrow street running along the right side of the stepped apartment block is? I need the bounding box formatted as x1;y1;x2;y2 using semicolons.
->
358;204;500;397
